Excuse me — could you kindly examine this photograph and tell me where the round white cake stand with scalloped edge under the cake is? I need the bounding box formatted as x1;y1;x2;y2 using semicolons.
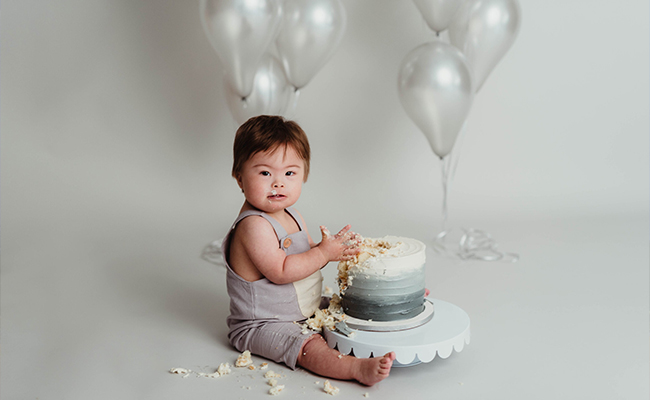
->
324;299;470;367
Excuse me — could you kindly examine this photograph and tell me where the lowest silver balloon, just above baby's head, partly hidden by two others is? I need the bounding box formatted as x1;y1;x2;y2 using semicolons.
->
225;54;293;125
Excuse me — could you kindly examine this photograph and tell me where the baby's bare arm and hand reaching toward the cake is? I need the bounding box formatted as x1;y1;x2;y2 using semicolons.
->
237;218;359;284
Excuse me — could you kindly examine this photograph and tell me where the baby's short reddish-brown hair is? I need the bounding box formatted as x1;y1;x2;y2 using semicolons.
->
232;115;311;182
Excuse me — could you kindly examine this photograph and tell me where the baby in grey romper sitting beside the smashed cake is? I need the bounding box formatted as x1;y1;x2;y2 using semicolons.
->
222;115;395;385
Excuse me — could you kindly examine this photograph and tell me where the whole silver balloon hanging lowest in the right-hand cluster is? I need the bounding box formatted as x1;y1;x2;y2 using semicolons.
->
398;41;474;158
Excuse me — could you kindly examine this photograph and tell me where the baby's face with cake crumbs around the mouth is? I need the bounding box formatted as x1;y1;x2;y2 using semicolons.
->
237;147;305;213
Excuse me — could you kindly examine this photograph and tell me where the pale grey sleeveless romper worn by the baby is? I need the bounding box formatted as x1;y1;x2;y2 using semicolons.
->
222;208;329;369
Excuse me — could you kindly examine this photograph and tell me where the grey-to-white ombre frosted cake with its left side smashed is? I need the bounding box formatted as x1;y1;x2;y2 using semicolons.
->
337;236;426;321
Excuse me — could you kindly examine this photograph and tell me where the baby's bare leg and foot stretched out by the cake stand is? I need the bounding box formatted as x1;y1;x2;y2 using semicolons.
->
298;335;395;386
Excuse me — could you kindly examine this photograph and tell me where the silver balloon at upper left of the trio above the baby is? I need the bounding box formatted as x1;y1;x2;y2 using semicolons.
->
201;0;282;98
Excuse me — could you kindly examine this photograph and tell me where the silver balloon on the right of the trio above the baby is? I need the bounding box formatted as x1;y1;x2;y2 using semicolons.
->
275;0;346;89
